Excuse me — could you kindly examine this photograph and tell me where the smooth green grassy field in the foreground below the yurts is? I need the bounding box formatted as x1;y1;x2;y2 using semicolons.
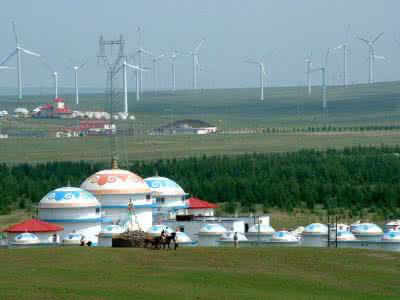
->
0;248;400;300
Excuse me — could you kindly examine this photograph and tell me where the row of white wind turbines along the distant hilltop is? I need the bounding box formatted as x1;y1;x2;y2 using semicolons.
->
0;22;394;112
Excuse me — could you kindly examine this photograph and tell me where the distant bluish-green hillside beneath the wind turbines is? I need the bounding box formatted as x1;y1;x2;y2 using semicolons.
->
0;82;400;129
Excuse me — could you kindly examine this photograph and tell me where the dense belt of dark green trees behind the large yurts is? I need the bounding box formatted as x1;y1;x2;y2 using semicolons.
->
0;146;400;213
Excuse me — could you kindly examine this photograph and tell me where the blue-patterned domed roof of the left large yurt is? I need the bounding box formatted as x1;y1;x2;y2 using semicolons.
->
39;187;100;208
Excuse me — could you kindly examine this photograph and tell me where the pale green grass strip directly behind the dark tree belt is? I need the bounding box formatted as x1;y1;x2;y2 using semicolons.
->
0;131;400;165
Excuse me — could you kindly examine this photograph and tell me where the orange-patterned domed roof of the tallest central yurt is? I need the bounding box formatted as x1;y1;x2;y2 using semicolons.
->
81;169;151;195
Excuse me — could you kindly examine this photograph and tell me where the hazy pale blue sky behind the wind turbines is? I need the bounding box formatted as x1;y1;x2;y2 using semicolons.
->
0;0;400;89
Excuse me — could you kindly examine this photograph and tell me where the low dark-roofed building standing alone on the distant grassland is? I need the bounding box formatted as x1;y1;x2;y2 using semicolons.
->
156;119;218;134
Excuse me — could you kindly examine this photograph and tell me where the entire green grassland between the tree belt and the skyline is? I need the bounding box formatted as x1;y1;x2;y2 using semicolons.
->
0;82;400;162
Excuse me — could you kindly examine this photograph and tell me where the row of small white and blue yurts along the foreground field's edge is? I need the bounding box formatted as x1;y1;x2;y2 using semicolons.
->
3;219;400;251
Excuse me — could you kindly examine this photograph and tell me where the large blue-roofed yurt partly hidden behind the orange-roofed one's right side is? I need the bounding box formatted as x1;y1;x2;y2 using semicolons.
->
144;176;187;221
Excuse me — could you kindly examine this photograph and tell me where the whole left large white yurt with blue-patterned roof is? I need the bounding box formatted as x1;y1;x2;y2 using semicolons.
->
38;187;101;244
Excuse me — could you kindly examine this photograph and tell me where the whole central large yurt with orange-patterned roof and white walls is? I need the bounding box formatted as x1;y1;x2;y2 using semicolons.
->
81;160;153;231
